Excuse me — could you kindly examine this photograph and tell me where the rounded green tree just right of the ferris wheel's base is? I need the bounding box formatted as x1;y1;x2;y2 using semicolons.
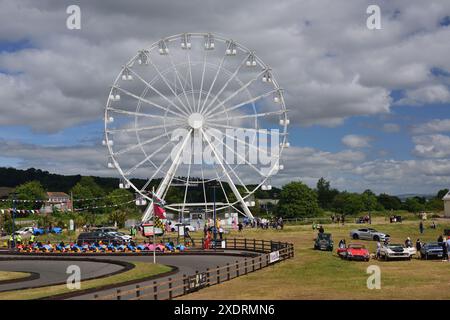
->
277;181;320;218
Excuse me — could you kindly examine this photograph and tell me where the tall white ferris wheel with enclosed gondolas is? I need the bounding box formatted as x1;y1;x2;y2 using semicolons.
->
103;33;289;222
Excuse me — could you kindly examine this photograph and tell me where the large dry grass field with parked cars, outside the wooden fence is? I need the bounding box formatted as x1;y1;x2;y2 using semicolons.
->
182;218;450;300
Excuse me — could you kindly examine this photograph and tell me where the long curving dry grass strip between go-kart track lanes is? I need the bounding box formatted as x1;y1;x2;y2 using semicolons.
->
0;262;170;300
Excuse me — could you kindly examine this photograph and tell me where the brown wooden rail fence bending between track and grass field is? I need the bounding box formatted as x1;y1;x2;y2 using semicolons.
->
93;238;294;300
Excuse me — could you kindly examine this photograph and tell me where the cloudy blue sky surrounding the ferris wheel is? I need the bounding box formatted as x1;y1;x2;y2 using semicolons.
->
0;0;450;194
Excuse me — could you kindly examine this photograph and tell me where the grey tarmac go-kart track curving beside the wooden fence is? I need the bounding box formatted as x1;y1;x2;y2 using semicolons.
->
0;239;293;300
